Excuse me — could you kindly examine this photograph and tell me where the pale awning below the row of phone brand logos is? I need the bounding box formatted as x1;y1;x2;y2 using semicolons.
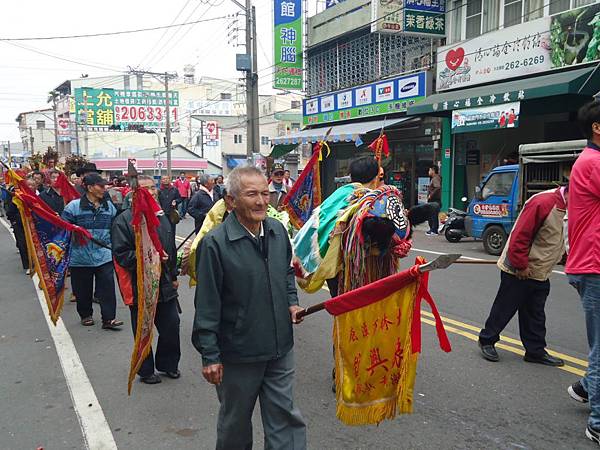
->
271;117;412;149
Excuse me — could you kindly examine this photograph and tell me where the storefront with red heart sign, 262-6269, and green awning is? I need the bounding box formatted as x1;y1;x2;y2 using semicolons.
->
407;3;600;208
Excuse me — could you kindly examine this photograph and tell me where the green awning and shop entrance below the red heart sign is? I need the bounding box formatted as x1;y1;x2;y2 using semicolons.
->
408;65;600;207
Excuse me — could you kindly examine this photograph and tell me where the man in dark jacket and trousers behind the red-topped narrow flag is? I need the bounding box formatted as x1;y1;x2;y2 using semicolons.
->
112;175;181;384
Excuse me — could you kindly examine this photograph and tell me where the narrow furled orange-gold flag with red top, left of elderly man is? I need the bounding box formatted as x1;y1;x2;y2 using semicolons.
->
127;188;164;394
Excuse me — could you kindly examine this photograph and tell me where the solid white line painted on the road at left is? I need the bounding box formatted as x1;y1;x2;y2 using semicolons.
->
0;218;117;450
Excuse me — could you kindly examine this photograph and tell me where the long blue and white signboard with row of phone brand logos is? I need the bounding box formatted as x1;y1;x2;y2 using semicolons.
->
302;72;427;125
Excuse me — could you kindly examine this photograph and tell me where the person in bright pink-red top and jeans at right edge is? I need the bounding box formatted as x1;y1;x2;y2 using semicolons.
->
565;101;600;444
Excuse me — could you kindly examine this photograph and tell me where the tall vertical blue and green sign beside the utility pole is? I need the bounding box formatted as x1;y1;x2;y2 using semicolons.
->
273;0;303;90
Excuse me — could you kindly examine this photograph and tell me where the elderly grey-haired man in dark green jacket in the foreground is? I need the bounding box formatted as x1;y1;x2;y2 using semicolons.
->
192;166;306;450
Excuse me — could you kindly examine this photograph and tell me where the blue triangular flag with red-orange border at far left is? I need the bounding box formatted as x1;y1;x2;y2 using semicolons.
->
9;166;92;325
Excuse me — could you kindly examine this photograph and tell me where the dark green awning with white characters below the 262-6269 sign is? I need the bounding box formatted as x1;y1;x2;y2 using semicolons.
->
407;67;600;116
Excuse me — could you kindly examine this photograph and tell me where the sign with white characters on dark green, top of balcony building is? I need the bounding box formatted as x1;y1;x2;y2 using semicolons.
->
371;0;446;37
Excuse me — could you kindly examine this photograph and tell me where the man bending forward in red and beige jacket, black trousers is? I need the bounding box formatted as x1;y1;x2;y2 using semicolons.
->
479;187;568;366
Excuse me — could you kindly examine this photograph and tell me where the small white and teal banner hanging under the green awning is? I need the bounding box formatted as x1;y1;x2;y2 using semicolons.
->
452;102;521;133
